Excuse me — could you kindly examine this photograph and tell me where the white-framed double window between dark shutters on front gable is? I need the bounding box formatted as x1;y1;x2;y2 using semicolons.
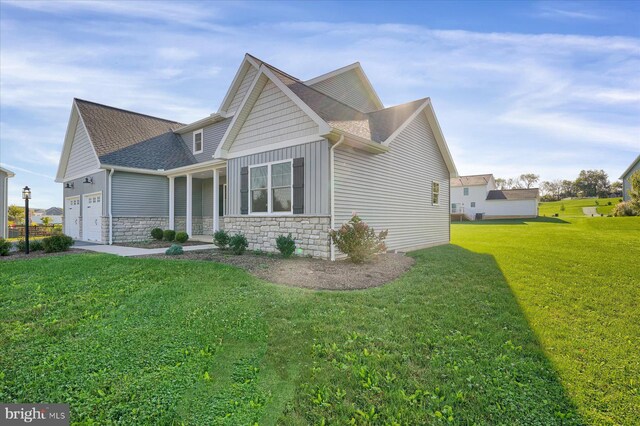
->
249;161;293;214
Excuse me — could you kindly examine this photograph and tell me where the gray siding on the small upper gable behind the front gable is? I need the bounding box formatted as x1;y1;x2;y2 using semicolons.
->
311;70;378;112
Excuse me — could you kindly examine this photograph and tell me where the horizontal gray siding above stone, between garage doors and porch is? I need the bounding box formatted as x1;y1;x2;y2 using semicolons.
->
112;171;169;216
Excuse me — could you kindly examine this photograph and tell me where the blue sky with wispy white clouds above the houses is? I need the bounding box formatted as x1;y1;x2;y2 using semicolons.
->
0;0;640;208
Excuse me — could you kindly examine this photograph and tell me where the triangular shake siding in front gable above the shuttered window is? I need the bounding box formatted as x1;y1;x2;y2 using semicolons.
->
229;80;319;153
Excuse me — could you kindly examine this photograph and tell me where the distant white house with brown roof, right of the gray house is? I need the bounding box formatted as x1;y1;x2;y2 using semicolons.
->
451;174;540;220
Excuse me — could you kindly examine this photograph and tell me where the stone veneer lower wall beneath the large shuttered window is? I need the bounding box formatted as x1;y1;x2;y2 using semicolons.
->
224;216;331;259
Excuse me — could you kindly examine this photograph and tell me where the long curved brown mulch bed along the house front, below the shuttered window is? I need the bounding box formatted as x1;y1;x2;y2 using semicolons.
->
139;250;415;290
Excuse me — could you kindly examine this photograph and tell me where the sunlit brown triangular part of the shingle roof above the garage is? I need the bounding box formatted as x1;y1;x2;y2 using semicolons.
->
75;99;184;157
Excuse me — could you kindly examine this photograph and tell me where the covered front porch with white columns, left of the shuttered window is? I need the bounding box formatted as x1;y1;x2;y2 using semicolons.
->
169;166;228;242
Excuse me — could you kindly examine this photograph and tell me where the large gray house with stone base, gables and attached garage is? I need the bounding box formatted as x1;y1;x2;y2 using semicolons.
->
57;54;457;259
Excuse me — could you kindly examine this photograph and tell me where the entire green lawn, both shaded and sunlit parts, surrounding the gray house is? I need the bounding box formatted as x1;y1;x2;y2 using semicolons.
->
0;218;640;425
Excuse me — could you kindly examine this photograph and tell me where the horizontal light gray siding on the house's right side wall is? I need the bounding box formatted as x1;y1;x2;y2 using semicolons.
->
334;114;449;250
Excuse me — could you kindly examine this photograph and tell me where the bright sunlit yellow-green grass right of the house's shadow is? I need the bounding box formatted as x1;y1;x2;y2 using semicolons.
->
452;217;640;424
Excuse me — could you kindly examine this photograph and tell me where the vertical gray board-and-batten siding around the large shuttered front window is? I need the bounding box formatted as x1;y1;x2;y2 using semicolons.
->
227;139;329;215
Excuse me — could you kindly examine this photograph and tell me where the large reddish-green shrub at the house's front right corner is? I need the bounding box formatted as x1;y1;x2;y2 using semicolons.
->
329;214;389;263
